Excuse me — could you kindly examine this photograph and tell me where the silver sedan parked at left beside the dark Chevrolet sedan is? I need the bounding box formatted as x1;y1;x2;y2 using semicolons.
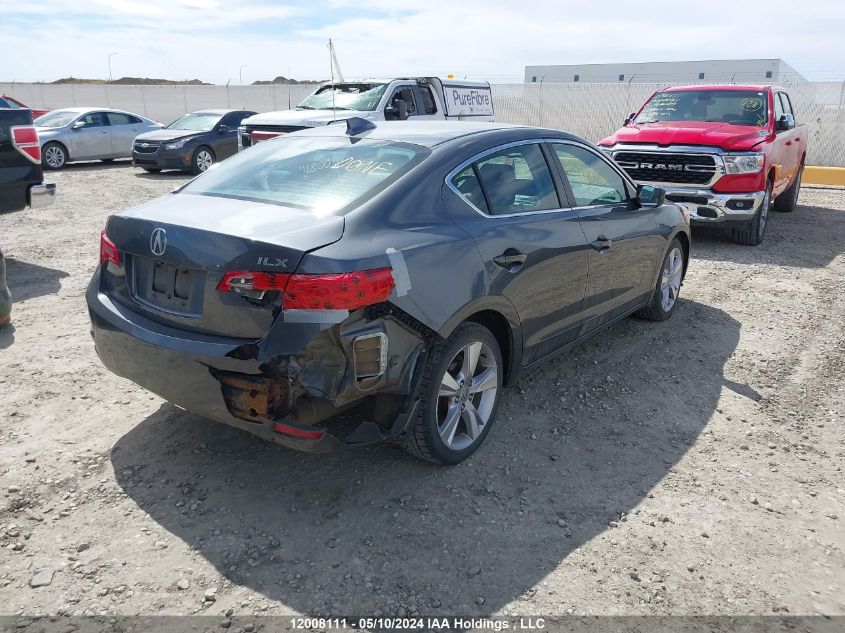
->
34;108;163;169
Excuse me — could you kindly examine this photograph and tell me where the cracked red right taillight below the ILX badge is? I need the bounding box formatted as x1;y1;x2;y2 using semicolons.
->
217;268;395;310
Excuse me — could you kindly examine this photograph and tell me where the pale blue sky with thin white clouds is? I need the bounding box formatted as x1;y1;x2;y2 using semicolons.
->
0;0;845;84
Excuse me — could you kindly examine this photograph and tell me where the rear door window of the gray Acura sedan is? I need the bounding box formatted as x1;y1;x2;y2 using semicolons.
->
474;144;560;215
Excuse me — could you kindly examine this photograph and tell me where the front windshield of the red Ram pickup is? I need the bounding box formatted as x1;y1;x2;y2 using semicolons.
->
634;90;769;127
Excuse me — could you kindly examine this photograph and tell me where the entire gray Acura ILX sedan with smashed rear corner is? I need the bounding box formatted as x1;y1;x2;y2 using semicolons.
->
86;118;690;464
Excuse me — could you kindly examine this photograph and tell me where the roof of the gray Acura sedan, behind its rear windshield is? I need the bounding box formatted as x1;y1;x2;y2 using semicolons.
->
286;119;575;148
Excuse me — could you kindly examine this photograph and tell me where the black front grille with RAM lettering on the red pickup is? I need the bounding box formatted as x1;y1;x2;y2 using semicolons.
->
613;151;721;185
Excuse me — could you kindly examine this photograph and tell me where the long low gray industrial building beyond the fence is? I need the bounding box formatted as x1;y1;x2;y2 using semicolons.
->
525;59;807;85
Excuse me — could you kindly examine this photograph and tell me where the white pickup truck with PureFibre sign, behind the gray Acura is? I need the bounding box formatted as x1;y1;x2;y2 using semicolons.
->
238;77;493;150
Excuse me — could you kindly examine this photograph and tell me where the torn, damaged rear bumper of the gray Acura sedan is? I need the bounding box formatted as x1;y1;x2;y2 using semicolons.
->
86;274;427;452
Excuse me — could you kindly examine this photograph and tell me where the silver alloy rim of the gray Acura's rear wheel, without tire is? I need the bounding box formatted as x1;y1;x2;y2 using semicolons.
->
437;341;499;451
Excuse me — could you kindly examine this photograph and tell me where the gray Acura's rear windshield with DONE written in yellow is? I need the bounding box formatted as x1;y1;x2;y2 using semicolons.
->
182;136;430;215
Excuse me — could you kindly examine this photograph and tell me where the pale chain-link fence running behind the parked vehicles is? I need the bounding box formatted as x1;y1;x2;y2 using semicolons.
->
0;82;845;167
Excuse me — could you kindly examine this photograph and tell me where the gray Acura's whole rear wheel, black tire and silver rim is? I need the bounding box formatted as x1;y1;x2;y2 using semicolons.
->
404;322;504;465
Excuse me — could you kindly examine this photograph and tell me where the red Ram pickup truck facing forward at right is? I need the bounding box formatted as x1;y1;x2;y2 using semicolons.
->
599;84;808;246
